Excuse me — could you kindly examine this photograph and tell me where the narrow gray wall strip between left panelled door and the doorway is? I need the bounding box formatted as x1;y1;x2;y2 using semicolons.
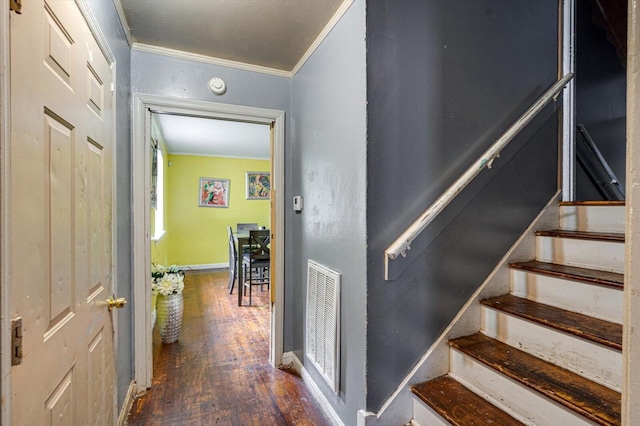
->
87;0;133;409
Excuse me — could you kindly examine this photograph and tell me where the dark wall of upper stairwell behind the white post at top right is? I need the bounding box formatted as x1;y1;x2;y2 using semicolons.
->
576;0;627;200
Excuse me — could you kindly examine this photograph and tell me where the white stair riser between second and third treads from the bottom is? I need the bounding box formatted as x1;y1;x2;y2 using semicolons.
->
482;306;622;392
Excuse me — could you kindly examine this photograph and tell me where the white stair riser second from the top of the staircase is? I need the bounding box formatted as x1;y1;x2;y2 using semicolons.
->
536;236;624;273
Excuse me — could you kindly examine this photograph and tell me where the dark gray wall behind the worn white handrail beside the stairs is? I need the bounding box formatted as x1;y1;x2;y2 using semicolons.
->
367;0;559;411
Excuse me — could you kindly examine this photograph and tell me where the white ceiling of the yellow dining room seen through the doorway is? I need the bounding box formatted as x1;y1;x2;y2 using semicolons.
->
156;114;271;160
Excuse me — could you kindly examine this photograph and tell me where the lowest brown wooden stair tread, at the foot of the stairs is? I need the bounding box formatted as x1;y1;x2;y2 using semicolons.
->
411;376;523;426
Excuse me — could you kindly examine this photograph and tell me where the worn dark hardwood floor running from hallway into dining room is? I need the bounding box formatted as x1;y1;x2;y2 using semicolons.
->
127;270;331;426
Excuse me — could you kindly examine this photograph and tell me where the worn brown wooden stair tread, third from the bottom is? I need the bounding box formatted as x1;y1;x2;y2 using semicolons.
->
481;294;622;350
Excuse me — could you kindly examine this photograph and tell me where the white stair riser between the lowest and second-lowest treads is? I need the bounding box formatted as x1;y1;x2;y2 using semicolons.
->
450;348;593;426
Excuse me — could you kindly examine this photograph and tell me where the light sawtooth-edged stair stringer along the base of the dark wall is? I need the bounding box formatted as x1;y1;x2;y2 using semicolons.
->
357;191;560;426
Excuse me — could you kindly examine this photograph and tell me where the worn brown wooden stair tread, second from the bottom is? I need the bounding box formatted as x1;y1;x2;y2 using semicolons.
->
449;333;621;425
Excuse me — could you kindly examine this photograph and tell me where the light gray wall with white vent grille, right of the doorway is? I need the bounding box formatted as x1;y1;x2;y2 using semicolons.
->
285;0;367;424
